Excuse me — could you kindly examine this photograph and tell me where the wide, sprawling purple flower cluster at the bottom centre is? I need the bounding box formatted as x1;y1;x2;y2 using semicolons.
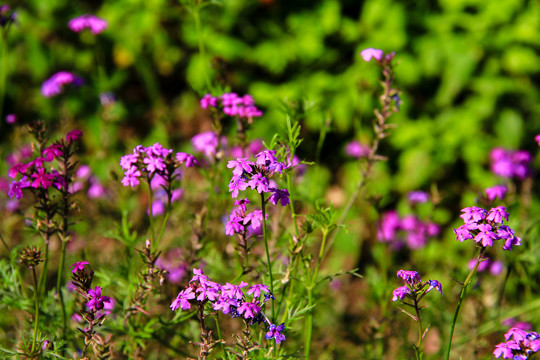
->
170;269;285;344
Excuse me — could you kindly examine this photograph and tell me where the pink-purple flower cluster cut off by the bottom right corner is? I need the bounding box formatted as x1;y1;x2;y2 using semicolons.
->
493;327;540;360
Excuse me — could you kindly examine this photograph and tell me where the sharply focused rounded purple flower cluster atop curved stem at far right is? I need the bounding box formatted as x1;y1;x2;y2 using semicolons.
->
454;206;521;250
